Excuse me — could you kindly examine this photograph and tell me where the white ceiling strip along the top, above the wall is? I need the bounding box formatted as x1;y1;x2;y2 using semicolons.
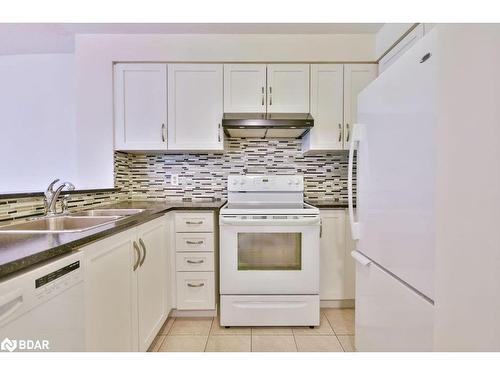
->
0;23;383;55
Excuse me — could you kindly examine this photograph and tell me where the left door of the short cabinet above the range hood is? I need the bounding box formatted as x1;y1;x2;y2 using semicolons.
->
224;64;266;113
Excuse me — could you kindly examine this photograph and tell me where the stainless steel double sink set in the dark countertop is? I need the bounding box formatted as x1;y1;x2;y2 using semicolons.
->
0;208;144;233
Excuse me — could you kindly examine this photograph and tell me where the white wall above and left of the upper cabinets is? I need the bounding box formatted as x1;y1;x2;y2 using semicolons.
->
75;34;375;188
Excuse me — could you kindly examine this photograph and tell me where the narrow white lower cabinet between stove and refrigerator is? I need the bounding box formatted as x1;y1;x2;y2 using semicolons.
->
319;209;355;301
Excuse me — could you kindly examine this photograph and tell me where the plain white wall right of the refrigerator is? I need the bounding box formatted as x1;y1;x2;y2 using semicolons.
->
432;24;500;351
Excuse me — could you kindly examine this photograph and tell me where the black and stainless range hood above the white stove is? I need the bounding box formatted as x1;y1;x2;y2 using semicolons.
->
222;113;314;138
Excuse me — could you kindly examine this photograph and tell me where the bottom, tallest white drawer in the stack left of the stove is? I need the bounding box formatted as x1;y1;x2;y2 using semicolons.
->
176;272;215;310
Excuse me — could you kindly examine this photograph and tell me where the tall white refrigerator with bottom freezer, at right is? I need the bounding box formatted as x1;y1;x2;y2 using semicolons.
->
349;28;439;351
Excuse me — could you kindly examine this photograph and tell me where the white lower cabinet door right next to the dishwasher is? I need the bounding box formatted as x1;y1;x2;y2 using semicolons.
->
83;231;137;352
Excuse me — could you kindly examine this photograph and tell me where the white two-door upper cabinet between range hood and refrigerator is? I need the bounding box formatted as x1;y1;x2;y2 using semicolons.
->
303;64;377;153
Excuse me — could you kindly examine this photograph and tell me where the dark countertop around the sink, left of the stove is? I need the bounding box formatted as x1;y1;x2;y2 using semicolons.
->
0;201;226;279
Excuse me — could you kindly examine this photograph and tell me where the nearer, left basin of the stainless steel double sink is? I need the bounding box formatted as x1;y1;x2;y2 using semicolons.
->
0;216;121;233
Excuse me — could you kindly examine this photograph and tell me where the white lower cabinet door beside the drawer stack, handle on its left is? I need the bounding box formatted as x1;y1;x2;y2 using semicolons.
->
137;218;168;351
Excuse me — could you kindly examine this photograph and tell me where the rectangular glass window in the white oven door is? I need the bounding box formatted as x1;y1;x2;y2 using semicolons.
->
238;233;302;271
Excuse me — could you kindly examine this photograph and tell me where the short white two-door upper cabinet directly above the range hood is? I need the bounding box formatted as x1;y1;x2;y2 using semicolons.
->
224;64;309;113
